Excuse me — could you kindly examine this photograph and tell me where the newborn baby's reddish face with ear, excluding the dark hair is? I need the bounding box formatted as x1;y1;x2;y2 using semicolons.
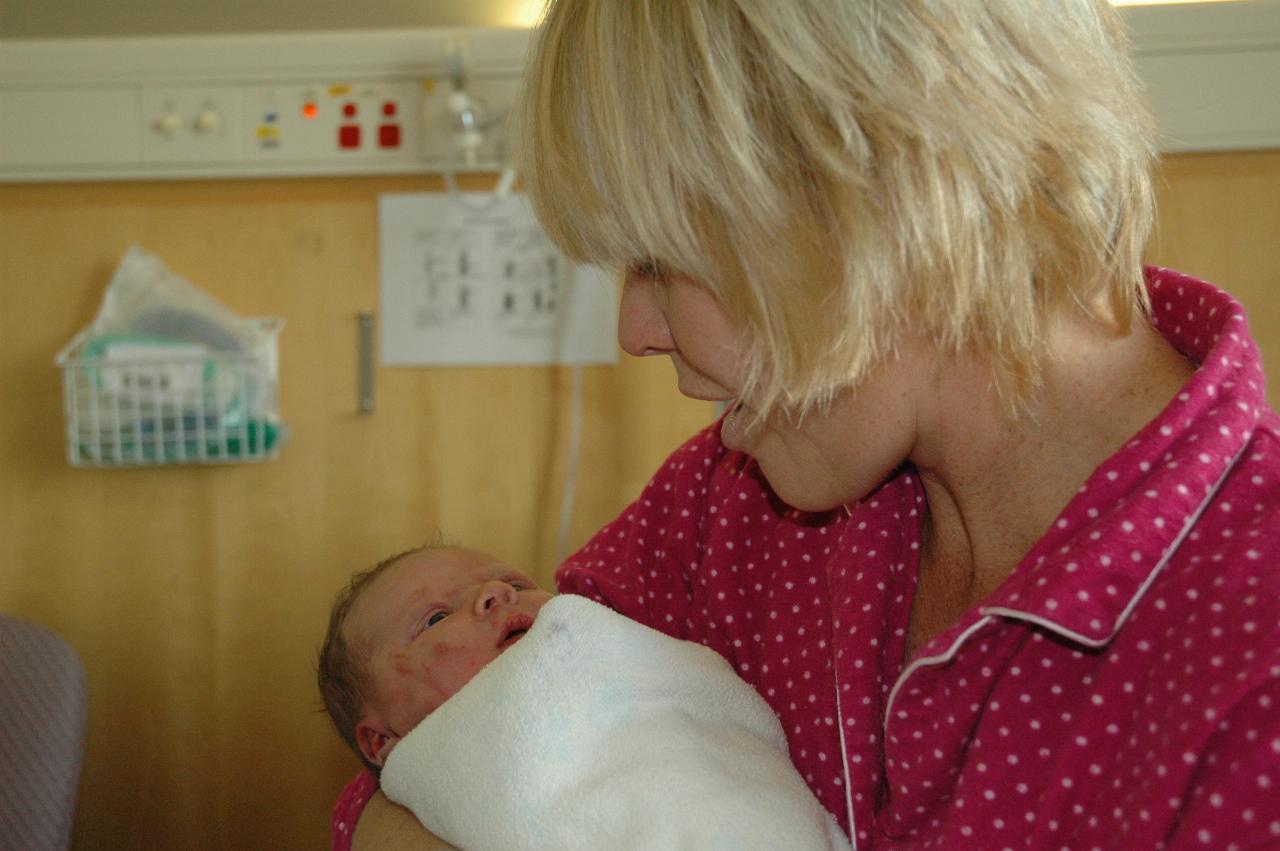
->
347;549;552;764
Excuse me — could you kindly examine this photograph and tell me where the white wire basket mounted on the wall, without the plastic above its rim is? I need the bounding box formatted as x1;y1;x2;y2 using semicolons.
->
56;319;285;467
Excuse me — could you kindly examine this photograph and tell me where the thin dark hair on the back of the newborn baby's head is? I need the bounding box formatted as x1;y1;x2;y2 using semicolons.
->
316;536;445;774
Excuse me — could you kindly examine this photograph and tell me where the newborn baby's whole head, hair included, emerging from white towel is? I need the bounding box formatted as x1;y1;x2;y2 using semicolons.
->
319;546;552;773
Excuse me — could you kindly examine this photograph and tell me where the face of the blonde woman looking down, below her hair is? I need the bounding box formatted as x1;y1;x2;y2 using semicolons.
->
618;266;931;511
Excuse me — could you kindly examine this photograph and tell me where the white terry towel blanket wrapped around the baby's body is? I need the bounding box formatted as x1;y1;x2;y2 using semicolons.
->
381;595;850;851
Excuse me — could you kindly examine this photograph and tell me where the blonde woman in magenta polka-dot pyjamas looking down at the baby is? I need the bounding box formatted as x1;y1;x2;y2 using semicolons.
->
343;0;1280;848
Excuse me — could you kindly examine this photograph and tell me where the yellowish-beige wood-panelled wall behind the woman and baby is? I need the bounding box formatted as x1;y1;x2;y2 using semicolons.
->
0;152;1280;851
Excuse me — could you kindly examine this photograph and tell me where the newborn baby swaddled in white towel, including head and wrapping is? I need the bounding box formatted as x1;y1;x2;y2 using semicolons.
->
320;548;849;851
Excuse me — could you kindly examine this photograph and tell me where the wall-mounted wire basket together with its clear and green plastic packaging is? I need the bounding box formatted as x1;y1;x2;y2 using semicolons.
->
56;248;287;467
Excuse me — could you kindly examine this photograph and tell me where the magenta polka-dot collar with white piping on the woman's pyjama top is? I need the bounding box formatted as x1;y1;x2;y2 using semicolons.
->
980;267;1266;646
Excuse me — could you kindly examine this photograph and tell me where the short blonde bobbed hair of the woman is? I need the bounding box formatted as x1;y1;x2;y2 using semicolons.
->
517;0;1153;412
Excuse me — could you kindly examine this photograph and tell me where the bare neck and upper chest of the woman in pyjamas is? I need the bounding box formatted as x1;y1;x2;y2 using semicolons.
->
909;308;1193;651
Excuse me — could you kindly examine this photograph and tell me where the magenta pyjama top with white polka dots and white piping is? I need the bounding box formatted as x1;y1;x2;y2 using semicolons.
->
558;269;1280;851
